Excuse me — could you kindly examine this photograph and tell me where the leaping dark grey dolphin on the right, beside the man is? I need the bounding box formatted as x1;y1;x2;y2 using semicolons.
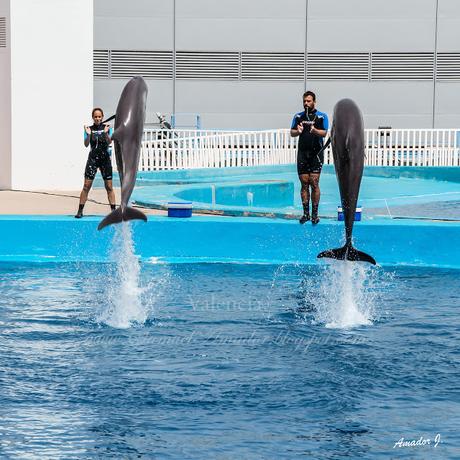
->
318;99;375;265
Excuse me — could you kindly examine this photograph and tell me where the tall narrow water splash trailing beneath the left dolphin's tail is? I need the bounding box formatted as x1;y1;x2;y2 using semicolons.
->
98;222;149;329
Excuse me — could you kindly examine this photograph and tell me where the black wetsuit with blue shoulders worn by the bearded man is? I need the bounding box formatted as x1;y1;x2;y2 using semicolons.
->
291;109;329;175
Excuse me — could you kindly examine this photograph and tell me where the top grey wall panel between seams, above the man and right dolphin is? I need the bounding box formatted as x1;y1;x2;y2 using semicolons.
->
308;0;435;52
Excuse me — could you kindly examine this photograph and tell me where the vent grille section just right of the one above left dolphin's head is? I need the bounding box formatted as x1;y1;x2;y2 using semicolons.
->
176;51;240;80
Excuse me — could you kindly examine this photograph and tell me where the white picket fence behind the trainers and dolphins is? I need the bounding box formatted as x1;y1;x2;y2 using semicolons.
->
139;129;460;171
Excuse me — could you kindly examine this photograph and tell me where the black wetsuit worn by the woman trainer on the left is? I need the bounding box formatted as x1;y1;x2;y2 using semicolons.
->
85;124;113;180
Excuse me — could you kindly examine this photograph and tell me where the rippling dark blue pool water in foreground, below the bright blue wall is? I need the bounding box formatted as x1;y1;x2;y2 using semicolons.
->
0;258;460;459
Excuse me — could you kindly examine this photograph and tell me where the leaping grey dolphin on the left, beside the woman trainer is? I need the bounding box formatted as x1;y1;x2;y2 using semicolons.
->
97;77;148;234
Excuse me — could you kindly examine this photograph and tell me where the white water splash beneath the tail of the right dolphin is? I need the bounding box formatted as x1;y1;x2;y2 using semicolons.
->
309;261;383;329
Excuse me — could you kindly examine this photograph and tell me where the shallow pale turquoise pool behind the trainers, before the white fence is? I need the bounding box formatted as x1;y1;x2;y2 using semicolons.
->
128;165;460;220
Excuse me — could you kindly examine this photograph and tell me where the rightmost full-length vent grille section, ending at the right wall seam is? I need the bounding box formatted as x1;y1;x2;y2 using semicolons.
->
371;53;434;81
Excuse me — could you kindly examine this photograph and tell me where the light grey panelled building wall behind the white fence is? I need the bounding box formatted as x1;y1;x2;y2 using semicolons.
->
94;0;460;129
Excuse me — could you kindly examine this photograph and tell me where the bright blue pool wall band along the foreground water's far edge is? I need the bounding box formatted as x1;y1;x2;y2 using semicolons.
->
0;216;460;268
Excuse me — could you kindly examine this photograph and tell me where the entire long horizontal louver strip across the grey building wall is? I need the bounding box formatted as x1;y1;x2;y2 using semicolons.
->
91;49;460;82
